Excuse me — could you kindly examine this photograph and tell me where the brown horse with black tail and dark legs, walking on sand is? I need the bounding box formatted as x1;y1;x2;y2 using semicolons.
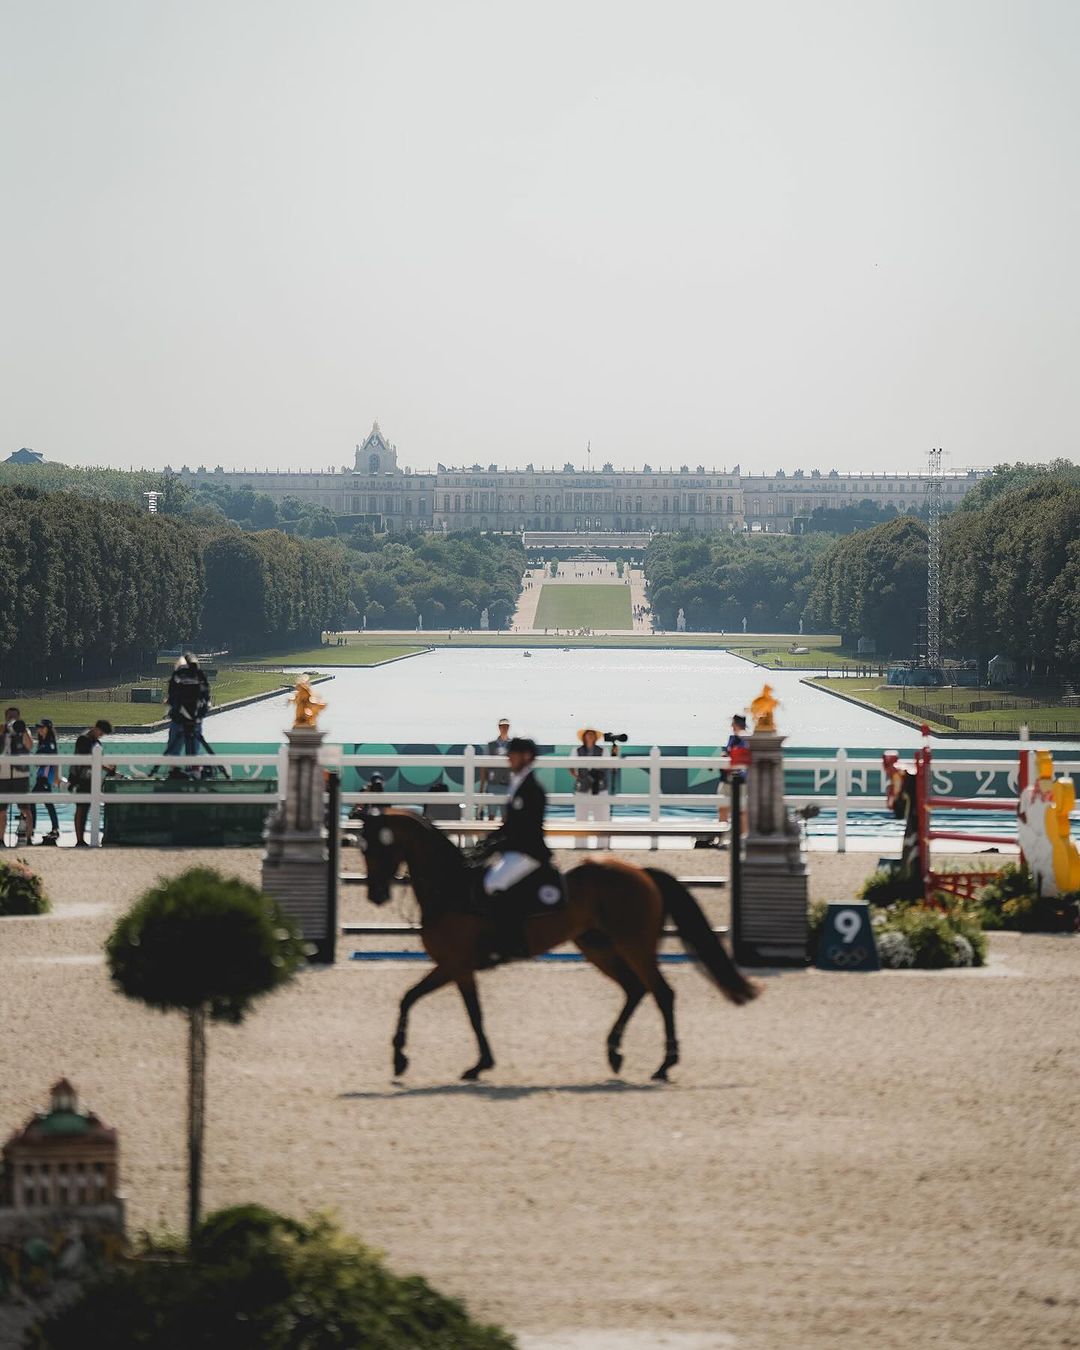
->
359;807;759;1081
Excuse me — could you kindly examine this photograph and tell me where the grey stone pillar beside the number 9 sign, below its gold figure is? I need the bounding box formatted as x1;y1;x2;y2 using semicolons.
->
732;730;809;965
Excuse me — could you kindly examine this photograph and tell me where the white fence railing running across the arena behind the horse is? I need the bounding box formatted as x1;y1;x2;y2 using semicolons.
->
0;745;1080;853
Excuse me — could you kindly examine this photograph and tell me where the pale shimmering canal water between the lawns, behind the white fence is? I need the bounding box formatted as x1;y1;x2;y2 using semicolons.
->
195;648;1053;753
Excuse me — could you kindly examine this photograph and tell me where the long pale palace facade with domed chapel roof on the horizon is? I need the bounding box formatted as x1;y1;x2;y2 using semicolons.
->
180;423;981;533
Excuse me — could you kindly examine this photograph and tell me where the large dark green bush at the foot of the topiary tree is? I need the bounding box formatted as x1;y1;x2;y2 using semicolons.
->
27;1206;514;1350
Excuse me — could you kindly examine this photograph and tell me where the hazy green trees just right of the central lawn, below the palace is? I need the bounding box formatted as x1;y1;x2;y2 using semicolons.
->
645;535;830;633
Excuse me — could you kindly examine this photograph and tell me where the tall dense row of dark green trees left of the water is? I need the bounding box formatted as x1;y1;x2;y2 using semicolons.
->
0;487;351;686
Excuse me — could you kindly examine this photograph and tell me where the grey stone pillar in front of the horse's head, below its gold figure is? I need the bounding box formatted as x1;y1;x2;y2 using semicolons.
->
262;726;338;964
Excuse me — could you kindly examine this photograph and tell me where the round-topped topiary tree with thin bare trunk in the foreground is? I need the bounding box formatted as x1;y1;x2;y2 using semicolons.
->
105;867;304;1235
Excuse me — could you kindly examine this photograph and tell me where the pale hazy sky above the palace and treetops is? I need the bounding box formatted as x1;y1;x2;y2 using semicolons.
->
0;0;1080;473
